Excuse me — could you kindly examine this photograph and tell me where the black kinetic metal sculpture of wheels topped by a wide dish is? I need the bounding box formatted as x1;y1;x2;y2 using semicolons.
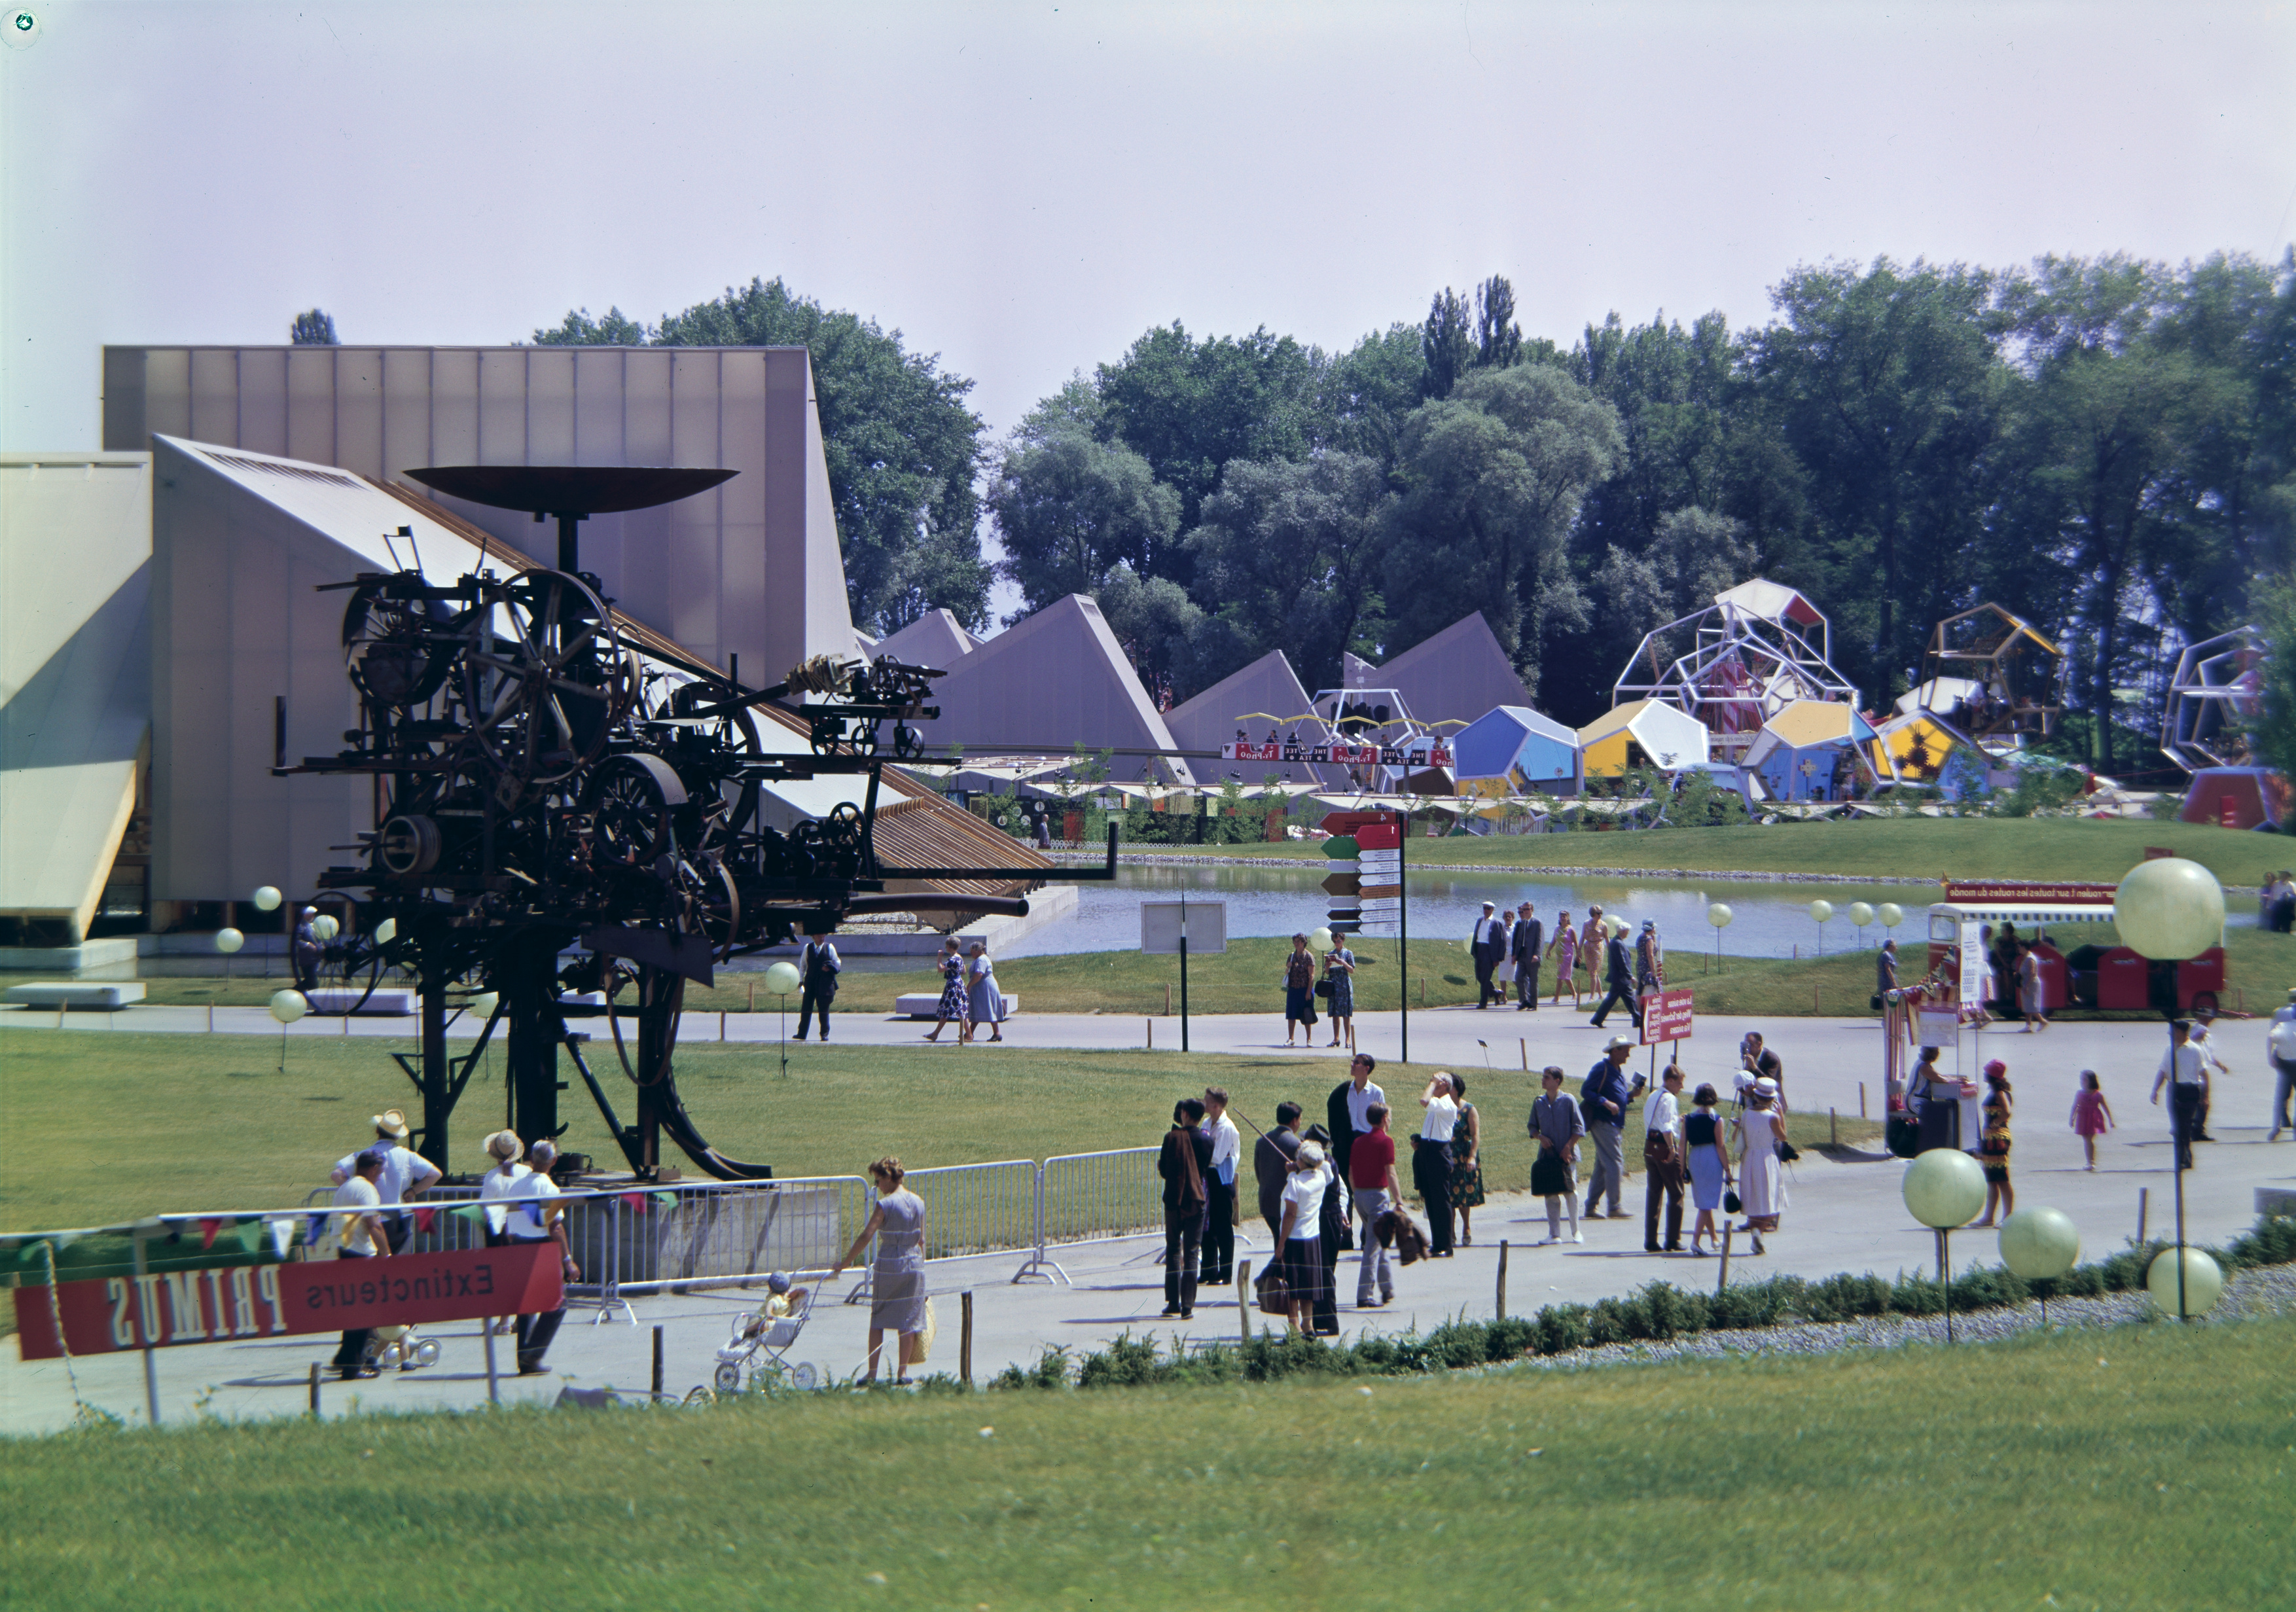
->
273;466;1116;1180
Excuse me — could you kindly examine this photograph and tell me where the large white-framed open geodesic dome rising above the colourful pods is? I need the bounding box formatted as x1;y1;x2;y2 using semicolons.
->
1609;577;1857;762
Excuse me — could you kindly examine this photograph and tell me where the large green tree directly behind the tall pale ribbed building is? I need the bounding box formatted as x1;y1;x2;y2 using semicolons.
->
535;278;992;636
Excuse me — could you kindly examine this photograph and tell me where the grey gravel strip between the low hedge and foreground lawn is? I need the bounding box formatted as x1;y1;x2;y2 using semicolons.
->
1522;1265;2296;1371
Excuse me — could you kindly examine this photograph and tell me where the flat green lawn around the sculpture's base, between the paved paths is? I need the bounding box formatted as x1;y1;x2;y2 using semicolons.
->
0;1031;1878;1231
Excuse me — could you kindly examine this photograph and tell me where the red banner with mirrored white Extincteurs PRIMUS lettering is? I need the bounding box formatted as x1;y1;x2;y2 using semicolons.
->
16;1242;565;1359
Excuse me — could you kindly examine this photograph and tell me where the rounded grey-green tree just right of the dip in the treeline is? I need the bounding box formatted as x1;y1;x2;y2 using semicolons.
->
987;427;1180;613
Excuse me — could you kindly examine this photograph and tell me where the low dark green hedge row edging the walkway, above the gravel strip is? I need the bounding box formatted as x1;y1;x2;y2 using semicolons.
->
990;1215;2296;1389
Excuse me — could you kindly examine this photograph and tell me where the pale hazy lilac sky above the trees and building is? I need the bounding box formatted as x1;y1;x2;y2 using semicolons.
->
0;0;2296;611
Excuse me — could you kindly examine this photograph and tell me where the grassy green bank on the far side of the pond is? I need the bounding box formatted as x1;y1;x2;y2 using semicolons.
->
1134;817;2296;895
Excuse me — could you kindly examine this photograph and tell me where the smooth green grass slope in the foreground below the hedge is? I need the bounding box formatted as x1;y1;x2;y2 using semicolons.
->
0;1320;2296;1612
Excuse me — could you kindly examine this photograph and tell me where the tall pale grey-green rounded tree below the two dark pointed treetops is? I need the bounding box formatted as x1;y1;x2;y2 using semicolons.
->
1387;365;1621;687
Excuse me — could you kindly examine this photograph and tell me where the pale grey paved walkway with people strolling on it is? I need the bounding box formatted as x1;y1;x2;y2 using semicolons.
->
0;1008;2296;1433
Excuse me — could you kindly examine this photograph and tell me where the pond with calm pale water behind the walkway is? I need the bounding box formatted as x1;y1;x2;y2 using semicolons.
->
1003;861;1938;958
